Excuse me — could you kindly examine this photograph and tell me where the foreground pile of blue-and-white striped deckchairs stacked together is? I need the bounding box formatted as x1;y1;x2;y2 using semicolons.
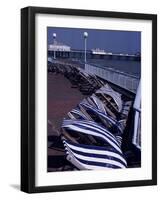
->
62;80;131;170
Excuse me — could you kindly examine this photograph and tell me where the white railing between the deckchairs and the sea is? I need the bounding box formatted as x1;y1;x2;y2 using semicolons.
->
85;64;140;93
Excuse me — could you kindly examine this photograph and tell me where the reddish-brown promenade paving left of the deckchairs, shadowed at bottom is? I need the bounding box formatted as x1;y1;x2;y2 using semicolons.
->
47;73;84;172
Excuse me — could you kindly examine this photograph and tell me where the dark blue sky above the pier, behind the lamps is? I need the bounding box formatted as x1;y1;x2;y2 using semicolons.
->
48;27;141;54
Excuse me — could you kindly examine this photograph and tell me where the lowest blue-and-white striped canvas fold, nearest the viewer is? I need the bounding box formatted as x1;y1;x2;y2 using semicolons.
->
63;139;127;170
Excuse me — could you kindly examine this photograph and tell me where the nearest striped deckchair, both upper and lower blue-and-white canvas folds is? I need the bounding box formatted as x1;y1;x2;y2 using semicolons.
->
62;120;127;170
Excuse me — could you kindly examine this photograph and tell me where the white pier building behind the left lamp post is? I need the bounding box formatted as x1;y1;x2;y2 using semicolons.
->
48;41;71;52
